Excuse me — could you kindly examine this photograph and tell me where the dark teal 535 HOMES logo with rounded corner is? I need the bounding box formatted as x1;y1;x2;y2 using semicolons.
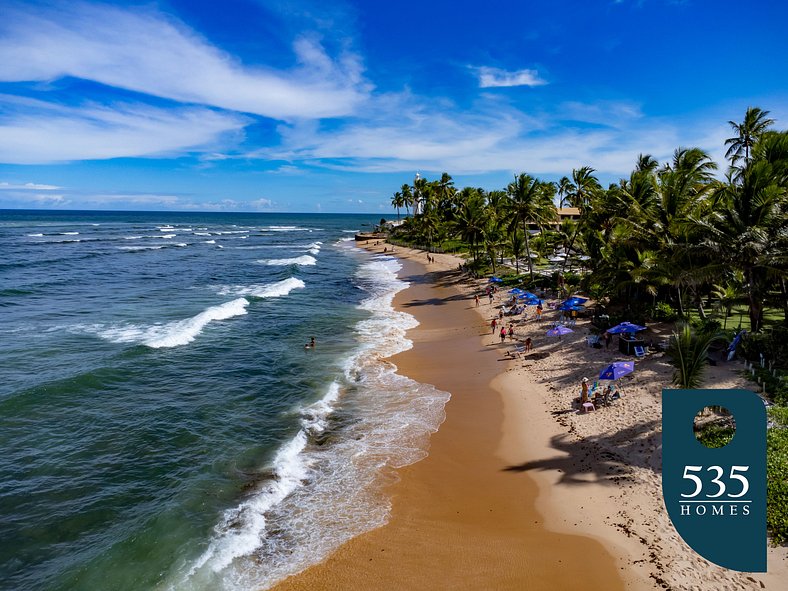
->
662;390;766;572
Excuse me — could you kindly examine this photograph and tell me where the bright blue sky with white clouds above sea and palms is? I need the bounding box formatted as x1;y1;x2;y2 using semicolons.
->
0;0;788;213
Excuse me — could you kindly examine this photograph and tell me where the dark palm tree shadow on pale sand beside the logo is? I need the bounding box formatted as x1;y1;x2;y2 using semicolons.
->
503;411;662;485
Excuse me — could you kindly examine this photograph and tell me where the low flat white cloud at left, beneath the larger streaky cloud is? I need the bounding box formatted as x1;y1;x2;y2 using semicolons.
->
0;95;246;164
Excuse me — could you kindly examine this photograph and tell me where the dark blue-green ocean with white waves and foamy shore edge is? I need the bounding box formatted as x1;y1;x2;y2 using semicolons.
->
0;210;449;591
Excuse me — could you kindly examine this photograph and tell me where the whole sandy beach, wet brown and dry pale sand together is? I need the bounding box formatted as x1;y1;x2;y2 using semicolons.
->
275;243;788;591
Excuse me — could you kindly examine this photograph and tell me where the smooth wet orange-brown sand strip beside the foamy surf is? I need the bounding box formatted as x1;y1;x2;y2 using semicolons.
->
274;245;632;591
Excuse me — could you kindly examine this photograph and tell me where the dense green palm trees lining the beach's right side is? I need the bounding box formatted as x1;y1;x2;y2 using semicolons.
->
392;107;788;543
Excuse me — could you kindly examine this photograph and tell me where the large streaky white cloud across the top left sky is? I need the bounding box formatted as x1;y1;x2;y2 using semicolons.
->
0;2;370;119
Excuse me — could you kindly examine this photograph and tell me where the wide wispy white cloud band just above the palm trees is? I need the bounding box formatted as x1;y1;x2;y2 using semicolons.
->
250;96;717;175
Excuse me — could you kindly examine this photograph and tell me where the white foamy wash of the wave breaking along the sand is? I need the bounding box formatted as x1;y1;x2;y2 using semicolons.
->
177;254;449;590
